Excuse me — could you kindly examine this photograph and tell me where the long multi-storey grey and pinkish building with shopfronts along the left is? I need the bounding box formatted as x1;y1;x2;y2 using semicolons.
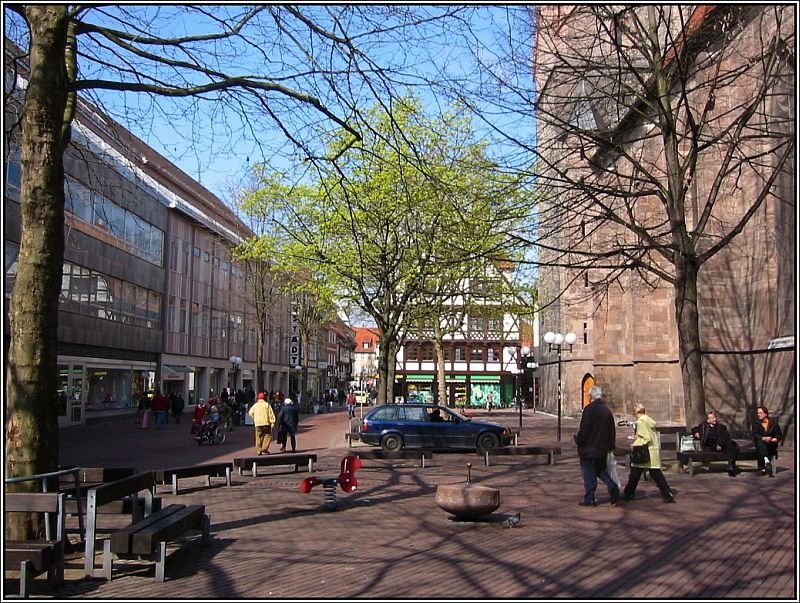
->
3;46;352;425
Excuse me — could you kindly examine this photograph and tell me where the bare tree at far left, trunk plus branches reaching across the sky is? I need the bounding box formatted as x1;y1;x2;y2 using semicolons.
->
4;4;468;531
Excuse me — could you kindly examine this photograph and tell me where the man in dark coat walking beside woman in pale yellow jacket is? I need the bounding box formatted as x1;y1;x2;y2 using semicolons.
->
575;385;619;507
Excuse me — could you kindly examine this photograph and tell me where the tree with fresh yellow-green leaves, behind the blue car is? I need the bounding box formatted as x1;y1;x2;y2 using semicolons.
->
244;97;530;402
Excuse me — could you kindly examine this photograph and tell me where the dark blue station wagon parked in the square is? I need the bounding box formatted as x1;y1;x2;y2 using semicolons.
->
361;403;513;451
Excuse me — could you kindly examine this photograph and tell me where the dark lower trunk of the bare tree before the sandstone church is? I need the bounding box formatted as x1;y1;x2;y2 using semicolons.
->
675;256;706;426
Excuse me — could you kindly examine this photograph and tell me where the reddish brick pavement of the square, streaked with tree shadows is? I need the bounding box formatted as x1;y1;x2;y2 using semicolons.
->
5;410;798;600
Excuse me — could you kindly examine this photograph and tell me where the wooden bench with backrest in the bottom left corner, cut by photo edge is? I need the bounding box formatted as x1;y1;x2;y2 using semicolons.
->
3;492;66;599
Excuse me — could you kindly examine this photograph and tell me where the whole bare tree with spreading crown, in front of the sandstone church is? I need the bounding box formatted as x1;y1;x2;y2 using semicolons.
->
536;5;795;424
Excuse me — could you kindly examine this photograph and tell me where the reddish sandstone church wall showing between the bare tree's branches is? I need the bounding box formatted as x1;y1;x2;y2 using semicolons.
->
534;5;796;438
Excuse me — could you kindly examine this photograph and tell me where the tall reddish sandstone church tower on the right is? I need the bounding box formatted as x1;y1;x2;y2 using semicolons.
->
533;5;796;431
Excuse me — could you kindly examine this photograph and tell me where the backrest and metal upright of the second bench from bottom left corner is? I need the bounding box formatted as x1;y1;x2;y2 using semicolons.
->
83;471;156;577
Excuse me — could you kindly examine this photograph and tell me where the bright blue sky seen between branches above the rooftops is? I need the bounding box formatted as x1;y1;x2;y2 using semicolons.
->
6;4;534;200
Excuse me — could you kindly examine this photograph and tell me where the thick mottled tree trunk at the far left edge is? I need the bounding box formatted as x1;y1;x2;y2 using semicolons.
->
5;5;69;538
